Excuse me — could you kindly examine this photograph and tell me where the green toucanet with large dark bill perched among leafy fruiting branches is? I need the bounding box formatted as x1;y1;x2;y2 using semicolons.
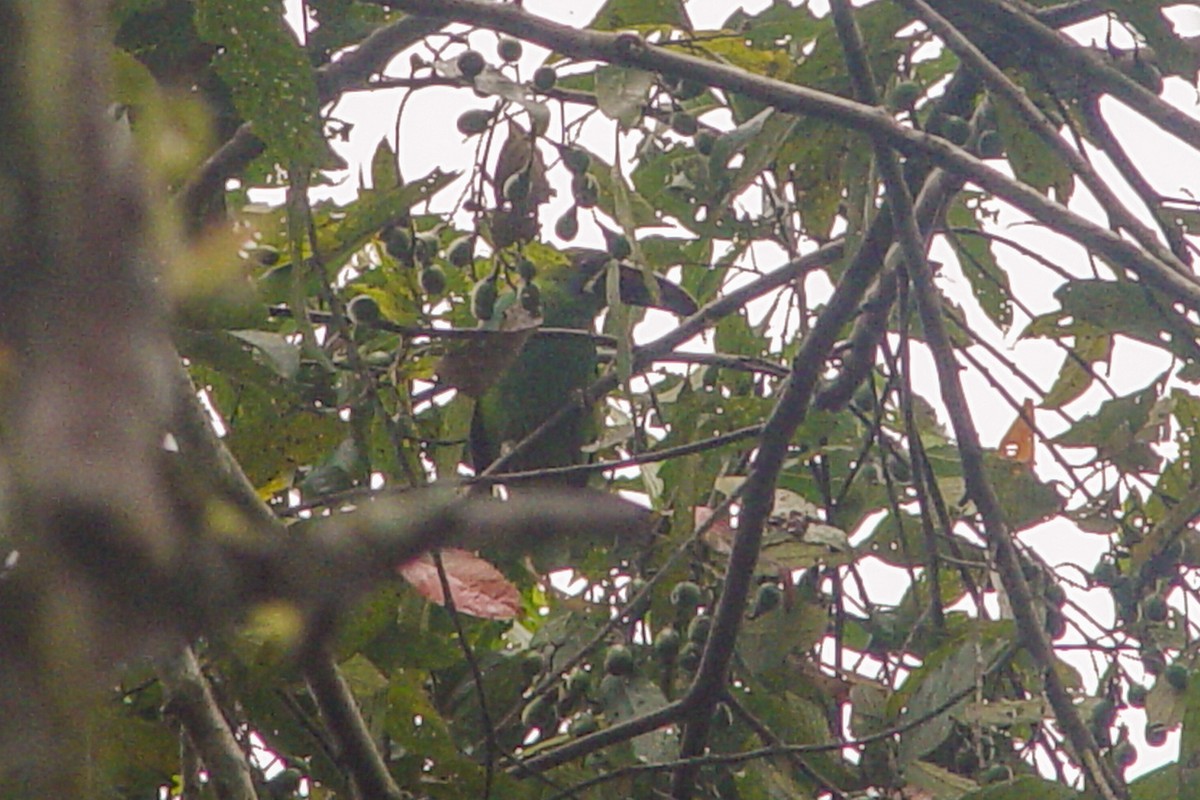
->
469;249;696;486
